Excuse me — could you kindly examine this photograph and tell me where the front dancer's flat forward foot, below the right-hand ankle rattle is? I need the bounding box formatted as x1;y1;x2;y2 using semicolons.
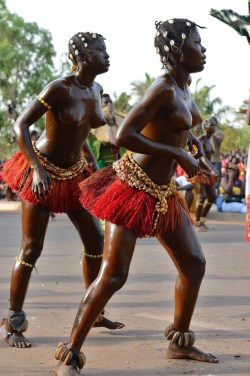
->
167;343;219;363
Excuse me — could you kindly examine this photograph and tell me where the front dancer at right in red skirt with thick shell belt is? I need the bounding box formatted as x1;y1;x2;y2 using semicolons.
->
55;19;218;376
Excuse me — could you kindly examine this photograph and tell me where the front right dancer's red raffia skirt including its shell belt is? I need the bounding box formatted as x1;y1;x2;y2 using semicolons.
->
79;153;193;238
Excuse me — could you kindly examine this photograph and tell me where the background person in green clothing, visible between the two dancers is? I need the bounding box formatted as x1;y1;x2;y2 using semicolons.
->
88;94;125;168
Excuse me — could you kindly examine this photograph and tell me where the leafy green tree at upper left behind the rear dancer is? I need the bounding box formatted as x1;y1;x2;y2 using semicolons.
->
0;0;55;158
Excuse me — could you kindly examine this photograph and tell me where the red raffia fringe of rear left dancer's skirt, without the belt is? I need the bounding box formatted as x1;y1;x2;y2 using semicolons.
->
2;151;89;213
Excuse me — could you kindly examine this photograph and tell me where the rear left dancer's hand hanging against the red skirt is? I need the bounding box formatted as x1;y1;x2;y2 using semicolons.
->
32;166;53;200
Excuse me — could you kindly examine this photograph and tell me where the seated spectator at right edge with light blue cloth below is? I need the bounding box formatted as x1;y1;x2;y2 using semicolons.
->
216;163;246;213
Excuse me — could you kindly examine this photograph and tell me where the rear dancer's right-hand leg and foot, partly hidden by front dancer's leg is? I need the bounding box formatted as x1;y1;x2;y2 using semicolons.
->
68;209;124;330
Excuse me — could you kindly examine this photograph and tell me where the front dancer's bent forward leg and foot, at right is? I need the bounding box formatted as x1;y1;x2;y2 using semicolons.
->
158;219;218;363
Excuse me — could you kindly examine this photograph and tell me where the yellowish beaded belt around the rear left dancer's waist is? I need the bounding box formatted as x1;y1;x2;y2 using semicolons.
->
33;142;88;180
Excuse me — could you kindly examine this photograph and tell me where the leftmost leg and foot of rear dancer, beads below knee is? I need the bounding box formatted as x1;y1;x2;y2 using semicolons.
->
0;201;49;348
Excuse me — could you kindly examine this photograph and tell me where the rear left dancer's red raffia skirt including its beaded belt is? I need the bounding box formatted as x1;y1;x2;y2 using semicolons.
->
2;145;90;213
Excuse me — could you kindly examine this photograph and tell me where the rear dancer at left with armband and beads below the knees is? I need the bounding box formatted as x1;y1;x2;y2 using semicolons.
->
0;32;123;348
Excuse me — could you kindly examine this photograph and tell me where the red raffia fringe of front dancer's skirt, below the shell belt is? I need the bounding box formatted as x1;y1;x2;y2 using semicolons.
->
79;166;193;238
